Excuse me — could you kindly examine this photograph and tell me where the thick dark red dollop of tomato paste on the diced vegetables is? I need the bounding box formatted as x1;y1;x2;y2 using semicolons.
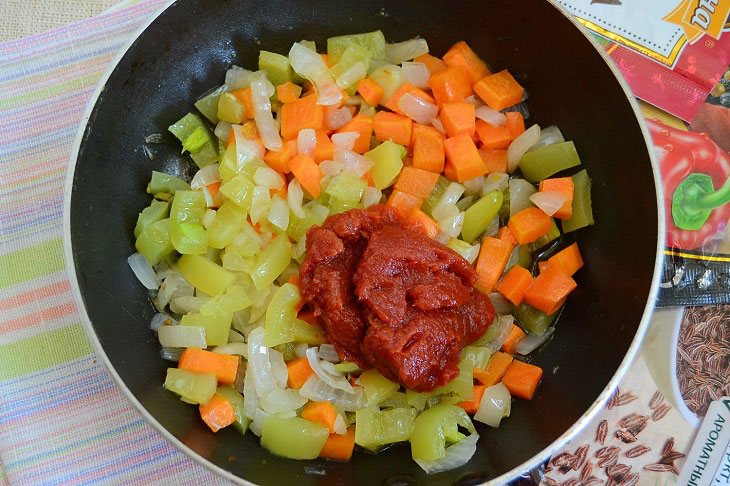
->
299;205;494;391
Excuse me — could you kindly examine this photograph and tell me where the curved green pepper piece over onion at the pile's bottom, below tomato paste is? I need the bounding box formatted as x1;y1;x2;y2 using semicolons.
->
406;403;475;461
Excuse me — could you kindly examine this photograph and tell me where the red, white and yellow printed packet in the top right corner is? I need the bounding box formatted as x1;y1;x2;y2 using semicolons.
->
559;0;730;121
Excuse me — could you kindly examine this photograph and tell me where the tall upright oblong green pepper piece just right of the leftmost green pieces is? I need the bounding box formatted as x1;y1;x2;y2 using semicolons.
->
170;190;208;255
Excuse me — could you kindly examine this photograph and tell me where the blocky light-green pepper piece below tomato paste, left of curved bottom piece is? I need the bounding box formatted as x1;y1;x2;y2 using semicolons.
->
355;407;416;450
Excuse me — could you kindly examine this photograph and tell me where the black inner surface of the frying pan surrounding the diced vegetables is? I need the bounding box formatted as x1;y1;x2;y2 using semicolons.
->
67;0;658;485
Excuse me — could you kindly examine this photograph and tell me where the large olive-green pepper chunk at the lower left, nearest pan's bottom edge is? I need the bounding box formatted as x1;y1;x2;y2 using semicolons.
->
261;414;329;459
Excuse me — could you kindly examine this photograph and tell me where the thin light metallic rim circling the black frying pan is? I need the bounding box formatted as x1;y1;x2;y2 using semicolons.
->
63;0;665;486
